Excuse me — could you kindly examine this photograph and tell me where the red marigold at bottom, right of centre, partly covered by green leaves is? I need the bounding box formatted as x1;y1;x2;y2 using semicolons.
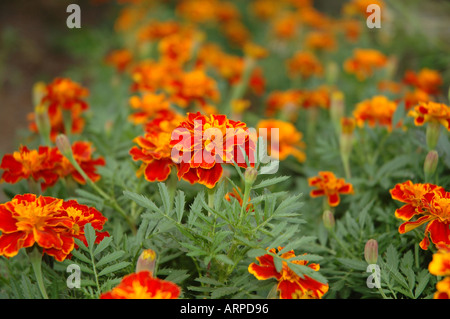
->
248;247;329;299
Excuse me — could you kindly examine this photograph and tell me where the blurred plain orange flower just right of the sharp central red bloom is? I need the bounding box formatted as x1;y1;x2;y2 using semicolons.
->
257;119;306;162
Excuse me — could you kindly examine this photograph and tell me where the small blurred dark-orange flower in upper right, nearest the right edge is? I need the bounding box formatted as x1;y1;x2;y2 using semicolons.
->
403;68;443;95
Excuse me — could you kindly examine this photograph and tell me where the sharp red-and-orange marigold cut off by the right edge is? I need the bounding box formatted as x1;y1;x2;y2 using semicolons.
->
391;181;450;250
